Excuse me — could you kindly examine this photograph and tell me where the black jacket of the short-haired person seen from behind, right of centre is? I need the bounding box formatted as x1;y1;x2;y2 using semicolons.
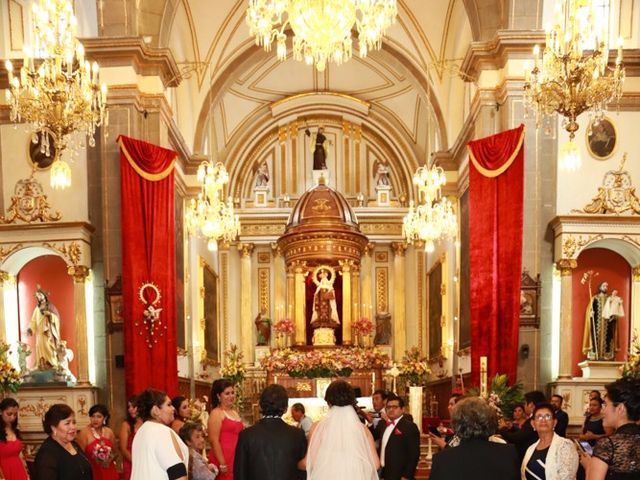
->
429;440;520;480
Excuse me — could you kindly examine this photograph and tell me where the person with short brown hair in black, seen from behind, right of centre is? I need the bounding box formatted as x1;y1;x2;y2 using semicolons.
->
429;397;520;480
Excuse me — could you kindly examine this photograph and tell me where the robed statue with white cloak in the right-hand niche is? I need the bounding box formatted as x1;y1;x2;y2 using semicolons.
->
582;282;624;360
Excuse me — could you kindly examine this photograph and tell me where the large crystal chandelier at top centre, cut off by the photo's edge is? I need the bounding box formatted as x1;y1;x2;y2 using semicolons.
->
247;0;398;72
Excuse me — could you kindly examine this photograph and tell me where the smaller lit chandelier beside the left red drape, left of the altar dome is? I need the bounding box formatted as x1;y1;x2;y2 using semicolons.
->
185;162;240;251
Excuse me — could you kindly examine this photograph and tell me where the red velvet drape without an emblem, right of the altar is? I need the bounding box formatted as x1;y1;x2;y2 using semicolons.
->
468;125;524;387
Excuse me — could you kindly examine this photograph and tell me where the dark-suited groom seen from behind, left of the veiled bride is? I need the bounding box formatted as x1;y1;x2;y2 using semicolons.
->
233;385;307;480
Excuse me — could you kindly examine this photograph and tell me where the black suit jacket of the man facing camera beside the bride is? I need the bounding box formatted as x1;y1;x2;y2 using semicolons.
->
376;415;420;480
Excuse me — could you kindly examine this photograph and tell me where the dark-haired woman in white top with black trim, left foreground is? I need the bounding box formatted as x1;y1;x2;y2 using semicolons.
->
131;388;189;480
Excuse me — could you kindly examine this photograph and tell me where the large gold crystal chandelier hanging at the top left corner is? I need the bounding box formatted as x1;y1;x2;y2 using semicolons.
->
5;0;107;189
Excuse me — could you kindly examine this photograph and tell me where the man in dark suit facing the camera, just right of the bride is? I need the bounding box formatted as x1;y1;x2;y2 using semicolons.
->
377;395;420;480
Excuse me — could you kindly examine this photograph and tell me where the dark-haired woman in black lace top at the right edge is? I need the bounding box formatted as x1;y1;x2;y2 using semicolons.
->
580;377;640;480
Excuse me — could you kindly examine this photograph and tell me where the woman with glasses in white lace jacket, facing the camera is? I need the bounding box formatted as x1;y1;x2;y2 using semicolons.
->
520;403;578;480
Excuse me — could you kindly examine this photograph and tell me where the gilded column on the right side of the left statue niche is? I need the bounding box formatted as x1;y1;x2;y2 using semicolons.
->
67;265;91;386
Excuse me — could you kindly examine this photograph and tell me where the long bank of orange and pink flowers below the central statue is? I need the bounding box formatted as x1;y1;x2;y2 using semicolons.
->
260;347;391;378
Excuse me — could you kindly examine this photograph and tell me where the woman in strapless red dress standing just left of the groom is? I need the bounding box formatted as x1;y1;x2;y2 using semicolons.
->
208;378;244;480
